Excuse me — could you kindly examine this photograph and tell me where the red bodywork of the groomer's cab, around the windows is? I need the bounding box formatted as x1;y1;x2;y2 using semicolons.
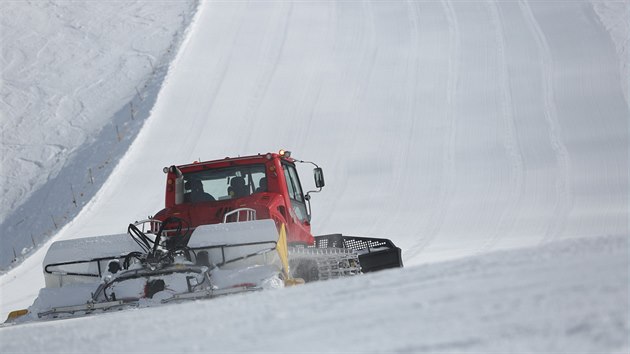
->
155;153;314;245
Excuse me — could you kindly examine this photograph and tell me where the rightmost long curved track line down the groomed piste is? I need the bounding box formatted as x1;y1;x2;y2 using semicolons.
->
518;0;572;242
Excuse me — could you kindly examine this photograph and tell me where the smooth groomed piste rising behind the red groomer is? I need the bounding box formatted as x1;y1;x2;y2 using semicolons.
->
4;2;628;257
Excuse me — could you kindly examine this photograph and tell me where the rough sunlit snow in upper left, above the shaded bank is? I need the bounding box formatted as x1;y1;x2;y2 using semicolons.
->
0;1;193;220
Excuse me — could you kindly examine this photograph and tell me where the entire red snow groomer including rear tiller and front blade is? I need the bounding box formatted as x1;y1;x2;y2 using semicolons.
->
8;151;402;322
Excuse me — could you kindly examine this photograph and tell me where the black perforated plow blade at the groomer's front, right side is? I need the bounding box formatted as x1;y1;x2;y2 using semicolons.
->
315;234;403;273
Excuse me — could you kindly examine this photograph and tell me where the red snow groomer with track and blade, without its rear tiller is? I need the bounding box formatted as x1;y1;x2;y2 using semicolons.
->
155;150;402;281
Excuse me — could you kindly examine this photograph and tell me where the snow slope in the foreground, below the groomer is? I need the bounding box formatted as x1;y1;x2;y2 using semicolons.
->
0;237;630;353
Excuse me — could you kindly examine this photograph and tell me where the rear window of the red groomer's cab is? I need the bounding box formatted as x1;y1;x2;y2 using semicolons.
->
184;164;267;203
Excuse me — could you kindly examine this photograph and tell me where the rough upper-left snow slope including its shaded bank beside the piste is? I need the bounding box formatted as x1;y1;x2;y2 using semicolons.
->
0;0;195;271
